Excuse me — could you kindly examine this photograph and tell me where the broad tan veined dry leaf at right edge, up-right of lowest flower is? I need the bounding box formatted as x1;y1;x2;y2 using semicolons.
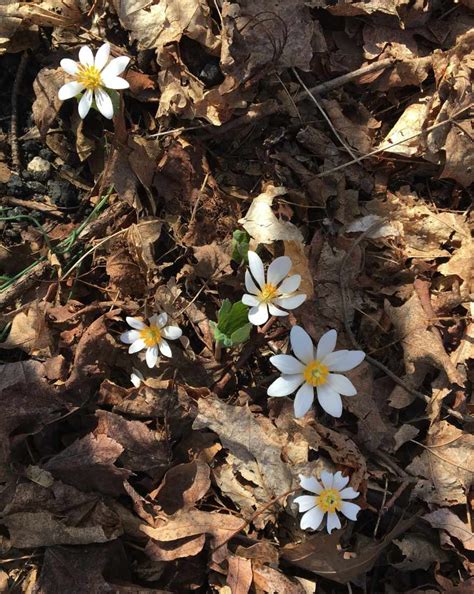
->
407;421;474;506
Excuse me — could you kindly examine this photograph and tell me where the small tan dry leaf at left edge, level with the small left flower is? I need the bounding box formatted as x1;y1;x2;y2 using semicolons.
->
0;301;53;356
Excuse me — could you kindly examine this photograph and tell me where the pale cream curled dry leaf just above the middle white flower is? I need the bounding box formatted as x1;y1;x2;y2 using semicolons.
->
239;185;303;243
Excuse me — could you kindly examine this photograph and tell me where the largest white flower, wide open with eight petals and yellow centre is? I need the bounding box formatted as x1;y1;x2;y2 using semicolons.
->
267;326;365;418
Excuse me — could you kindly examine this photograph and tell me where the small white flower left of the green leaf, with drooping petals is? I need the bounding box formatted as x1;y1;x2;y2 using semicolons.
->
120;313;182;369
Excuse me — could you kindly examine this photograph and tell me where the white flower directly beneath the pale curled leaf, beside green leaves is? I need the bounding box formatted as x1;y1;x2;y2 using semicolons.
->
242;251;306;326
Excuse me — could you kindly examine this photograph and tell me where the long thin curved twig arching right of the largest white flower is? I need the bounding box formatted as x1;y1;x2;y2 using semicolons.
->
339;219;471;422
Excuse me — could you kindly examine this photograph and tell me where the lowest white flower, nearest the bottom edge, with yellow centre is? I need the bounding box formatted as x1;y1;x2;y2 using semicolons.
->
294;470;360;534
